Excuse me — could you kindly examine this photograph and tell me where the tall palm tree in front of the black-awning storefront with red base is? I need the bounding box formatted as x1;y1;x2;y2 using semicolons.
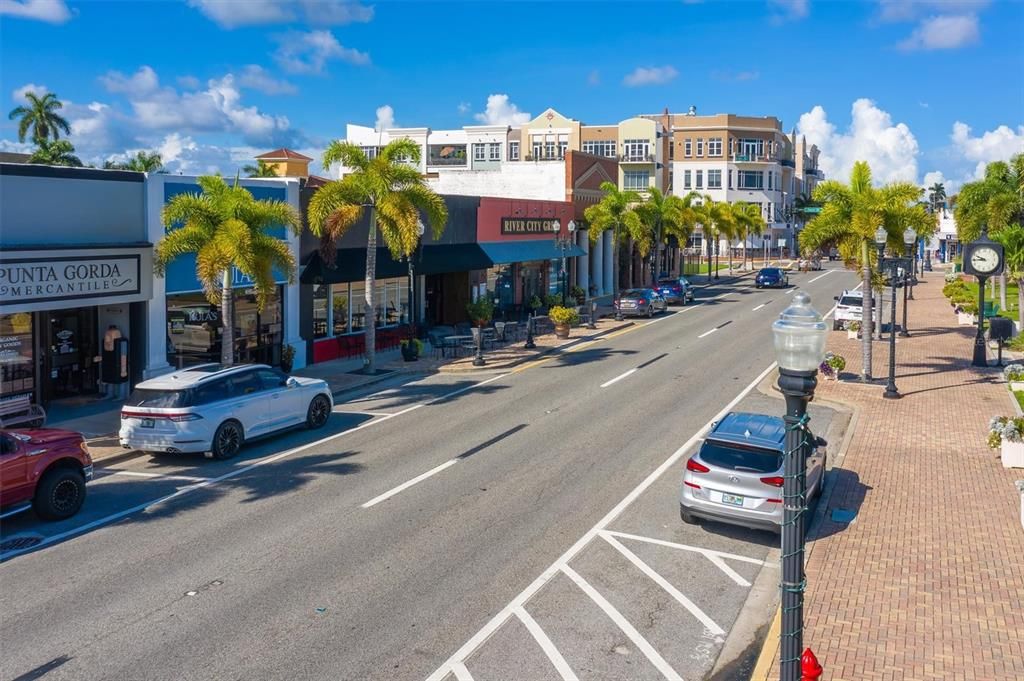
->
309;139;447;374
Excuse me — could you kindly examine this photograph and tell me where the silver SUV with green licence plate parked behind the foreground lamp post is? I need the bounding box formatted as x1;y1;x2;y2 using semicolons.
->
679;412;827;531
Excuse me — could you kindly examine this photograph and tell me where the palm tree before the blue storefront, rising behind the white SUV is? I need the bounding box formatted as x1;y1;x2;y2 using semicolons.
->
153;176;302;365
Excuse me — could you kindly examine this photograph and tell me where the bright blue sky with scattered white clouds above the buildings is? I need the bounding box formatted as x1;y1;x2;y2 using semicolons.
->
0;0;1024;188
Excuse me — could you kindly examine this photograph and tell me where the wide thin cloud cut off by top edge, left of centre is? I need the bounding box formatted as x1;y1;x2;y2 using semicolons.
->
188;0;374;29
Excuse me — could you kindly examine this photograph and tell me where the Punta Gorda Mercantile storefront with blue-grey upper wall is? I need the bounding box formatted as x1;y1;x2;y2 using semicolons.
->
0;164;153;406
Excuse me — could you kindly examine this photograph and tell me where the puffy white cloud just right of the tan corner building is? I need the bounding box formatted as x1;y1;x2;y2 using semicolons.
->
797;98;919;183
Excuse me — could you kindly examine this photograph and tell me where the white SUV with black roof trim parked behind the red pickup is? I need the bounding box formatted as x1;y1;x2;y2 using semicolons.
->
118;365;334;459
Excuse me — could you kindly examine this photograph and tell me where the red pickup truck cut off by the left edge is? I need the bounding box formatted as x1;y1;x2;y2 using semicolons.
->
0;428;92;520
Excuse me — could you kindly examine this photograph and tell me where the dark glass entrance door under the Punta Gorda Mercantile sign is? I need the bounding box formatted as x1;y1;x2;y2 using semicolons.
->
40;307;98;401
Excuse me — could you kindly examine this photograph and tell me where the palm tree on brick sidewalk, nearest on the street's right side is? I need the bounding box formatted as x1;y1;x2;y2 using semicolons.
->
800;161;922;381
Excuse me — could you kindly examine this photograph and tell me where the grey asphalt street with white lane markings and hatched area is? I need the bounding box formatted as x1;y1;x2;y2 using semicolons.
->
0;270;855;680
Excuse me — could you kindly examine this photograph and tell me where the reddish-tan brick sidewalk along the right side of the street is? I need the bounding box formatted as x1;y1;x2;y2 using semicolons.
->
768;272;1024;681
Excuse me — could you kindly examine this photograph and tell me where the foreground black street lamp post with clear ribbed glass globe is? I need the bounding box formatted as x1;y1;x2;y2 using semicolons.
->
772;291;828;681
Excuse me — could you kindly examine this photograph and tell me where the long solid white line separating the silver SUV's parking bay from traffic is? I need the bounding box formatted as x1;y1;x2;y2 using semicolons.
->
427;361;776;681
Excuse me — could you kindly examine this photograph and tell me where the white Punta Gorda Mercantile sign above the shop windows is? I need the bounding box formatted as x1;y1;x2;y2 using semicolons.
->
0;255;140;307
